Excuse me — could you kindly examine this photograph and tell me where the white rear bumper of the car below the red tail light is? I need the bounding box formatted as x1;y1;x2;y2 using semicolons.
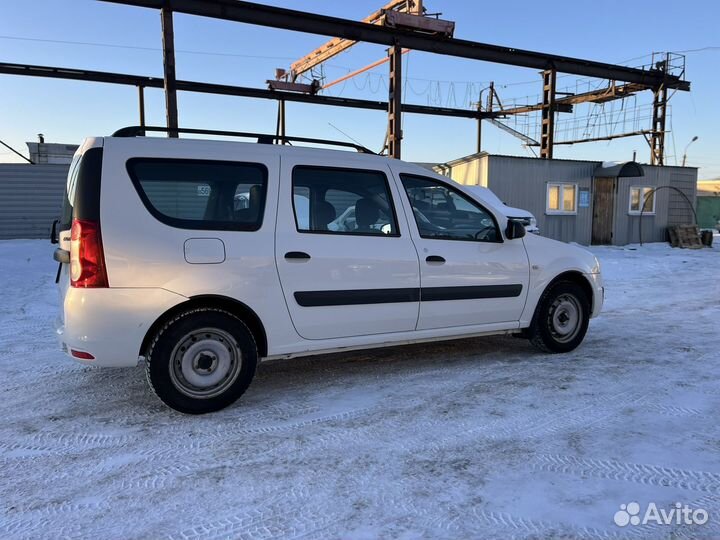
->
55;288;187;367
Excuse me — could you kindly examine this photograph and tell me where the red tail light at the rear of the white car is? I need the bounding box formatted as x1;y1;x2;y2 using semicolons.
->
70;219;108;288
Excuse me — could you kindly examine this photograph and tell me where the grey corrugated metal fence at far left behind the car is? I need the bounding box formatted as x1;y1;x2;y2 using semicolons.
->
0;163;69;239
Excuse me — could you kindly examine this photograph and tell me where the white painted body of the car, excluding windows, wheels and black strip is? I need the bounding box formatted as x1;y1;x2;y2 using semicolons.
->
53;137;602;366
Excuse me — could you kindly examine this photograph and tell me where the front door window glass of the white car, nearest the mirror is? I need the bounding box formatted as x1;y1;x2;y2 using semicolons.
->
400;174;502;242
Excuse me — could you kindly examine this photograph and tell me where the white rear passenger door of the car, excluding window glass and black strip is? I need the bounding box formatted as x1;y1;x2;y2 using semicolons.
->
275;153;420;339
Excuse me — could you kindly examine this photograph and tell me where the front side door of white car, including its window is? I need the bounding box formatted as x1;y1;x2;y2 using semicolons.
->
399;172;529;330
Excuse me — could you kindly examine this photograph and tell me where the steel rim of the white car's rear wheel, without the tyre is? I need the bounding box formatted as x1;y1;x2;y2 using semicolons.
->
170;328;242;399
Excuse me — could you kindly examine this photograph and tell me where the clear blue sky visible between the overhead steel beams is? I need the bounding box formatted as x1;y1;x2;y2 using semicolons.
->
0;0;720;178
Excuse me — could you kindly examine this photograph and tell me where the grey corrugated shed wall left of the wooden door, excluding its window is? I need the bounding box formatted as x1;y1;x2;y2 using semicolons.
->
480;156;598;244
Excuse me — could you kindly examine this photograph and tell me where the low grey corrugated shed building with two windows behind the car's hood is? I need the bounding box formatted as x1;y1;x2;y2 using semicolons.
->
433;152;697;246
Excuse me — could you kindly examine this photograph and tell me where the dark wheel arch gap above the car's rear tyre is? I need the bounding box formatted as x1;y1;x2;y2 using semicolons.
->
139;294;268;357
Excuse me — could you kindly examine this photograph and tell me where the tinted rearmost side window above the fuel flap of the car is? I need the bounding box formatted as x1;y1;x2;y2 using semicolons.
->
127;158;267;231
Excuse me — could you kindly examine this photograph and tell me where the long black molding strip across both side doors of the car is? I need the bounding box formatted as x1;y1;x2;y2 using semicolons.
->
294;284;522;307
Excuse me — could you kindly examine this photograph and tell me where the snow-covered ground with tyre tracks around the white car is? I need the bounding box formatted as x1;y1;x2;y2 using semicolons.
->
0;238;720;539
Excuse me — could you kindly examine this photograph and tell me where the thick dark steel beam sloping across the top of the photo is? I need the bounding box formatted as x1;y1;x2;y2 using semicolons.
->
101;0;690;90
